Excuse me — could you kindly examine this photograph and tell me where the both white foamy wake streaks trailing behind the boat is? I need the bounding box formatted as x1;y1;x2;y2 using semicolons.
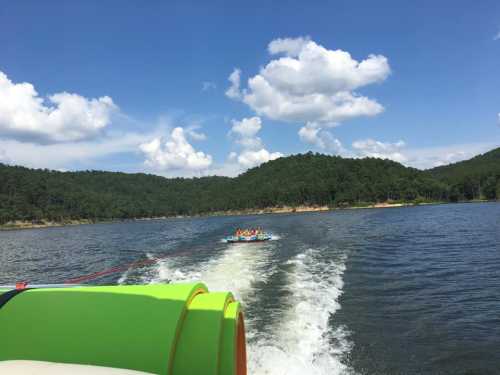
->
117;242;352;375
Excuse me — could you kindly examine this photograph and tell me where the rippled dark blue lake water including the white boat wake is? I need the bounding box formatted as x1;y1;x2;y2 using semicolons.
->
0;203;500;375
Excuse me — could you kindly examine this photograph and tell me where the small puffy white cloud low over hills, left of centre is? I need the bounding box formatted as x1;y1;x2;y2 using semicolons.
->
139;127;212;171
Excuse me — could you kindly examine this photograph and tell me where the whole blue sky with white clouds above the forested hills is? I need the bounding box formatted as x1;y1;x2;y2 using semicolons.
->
0;0;500;177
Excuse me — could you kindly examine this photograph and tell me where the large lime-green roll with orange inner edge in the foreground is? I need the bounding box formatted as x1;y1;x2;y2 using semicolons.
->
0;284;246;375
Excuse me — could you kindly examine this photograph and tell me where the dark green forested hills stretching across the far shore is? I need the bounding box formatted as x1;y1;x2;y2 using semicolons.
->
0;149;500;224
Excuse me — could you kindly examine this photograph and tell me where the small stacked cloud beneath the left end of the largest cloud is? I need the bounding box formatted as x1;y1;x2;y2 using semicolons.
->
228;117;283;168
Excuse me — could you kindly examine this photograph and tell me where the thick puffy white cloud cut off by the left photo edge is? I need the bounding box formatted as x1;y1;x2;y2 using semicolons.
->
0;71;118;144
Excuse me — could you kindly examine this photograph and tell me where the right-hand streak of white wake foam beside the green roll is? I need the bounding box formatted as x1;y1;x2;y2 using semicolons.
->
248;249;351;375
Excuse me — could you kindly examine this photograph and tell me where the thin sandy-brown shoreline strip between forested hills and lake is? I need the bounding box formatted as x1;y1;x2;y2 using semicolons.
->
0;200;490;231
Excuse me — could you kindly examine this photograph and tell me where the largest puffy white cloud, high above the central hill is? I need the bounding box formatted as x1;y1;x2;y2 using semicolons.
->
226;38;390;126
